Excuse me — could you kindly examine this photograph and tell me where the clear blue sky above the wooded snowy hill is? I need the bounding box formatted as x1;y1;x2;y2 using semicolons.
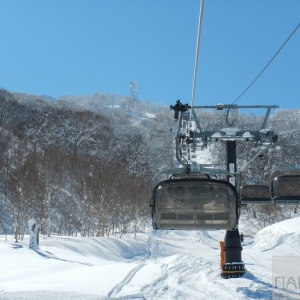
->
0;0;300;108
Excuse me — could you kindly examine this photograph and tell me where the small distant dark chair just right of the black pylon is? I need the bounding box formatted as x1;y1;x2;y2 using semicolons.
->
240;184;271;204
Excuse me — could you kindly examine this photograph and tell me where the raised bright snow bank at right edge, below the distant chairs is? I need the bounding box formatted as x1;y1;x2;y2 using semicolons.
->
254;217;300;251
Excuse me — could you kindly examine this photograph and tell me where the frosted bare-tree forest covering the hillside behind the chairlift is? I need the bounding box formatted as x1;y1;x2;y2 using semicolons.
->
0;90;300;240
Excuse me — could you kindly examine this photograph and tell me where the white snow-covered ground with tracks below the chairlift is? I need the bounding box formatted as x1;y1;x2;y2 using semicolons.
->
0;217;300;300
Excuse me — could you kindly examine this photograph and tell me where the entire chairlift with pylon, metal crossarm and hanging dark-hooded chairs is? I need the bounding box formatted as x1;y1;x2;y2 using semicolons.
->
150;100;300;278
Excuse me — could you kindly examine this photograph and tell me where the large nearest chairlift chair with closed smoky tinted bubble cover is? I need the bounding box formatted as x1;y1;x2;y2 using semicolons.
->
150;178;237;230
